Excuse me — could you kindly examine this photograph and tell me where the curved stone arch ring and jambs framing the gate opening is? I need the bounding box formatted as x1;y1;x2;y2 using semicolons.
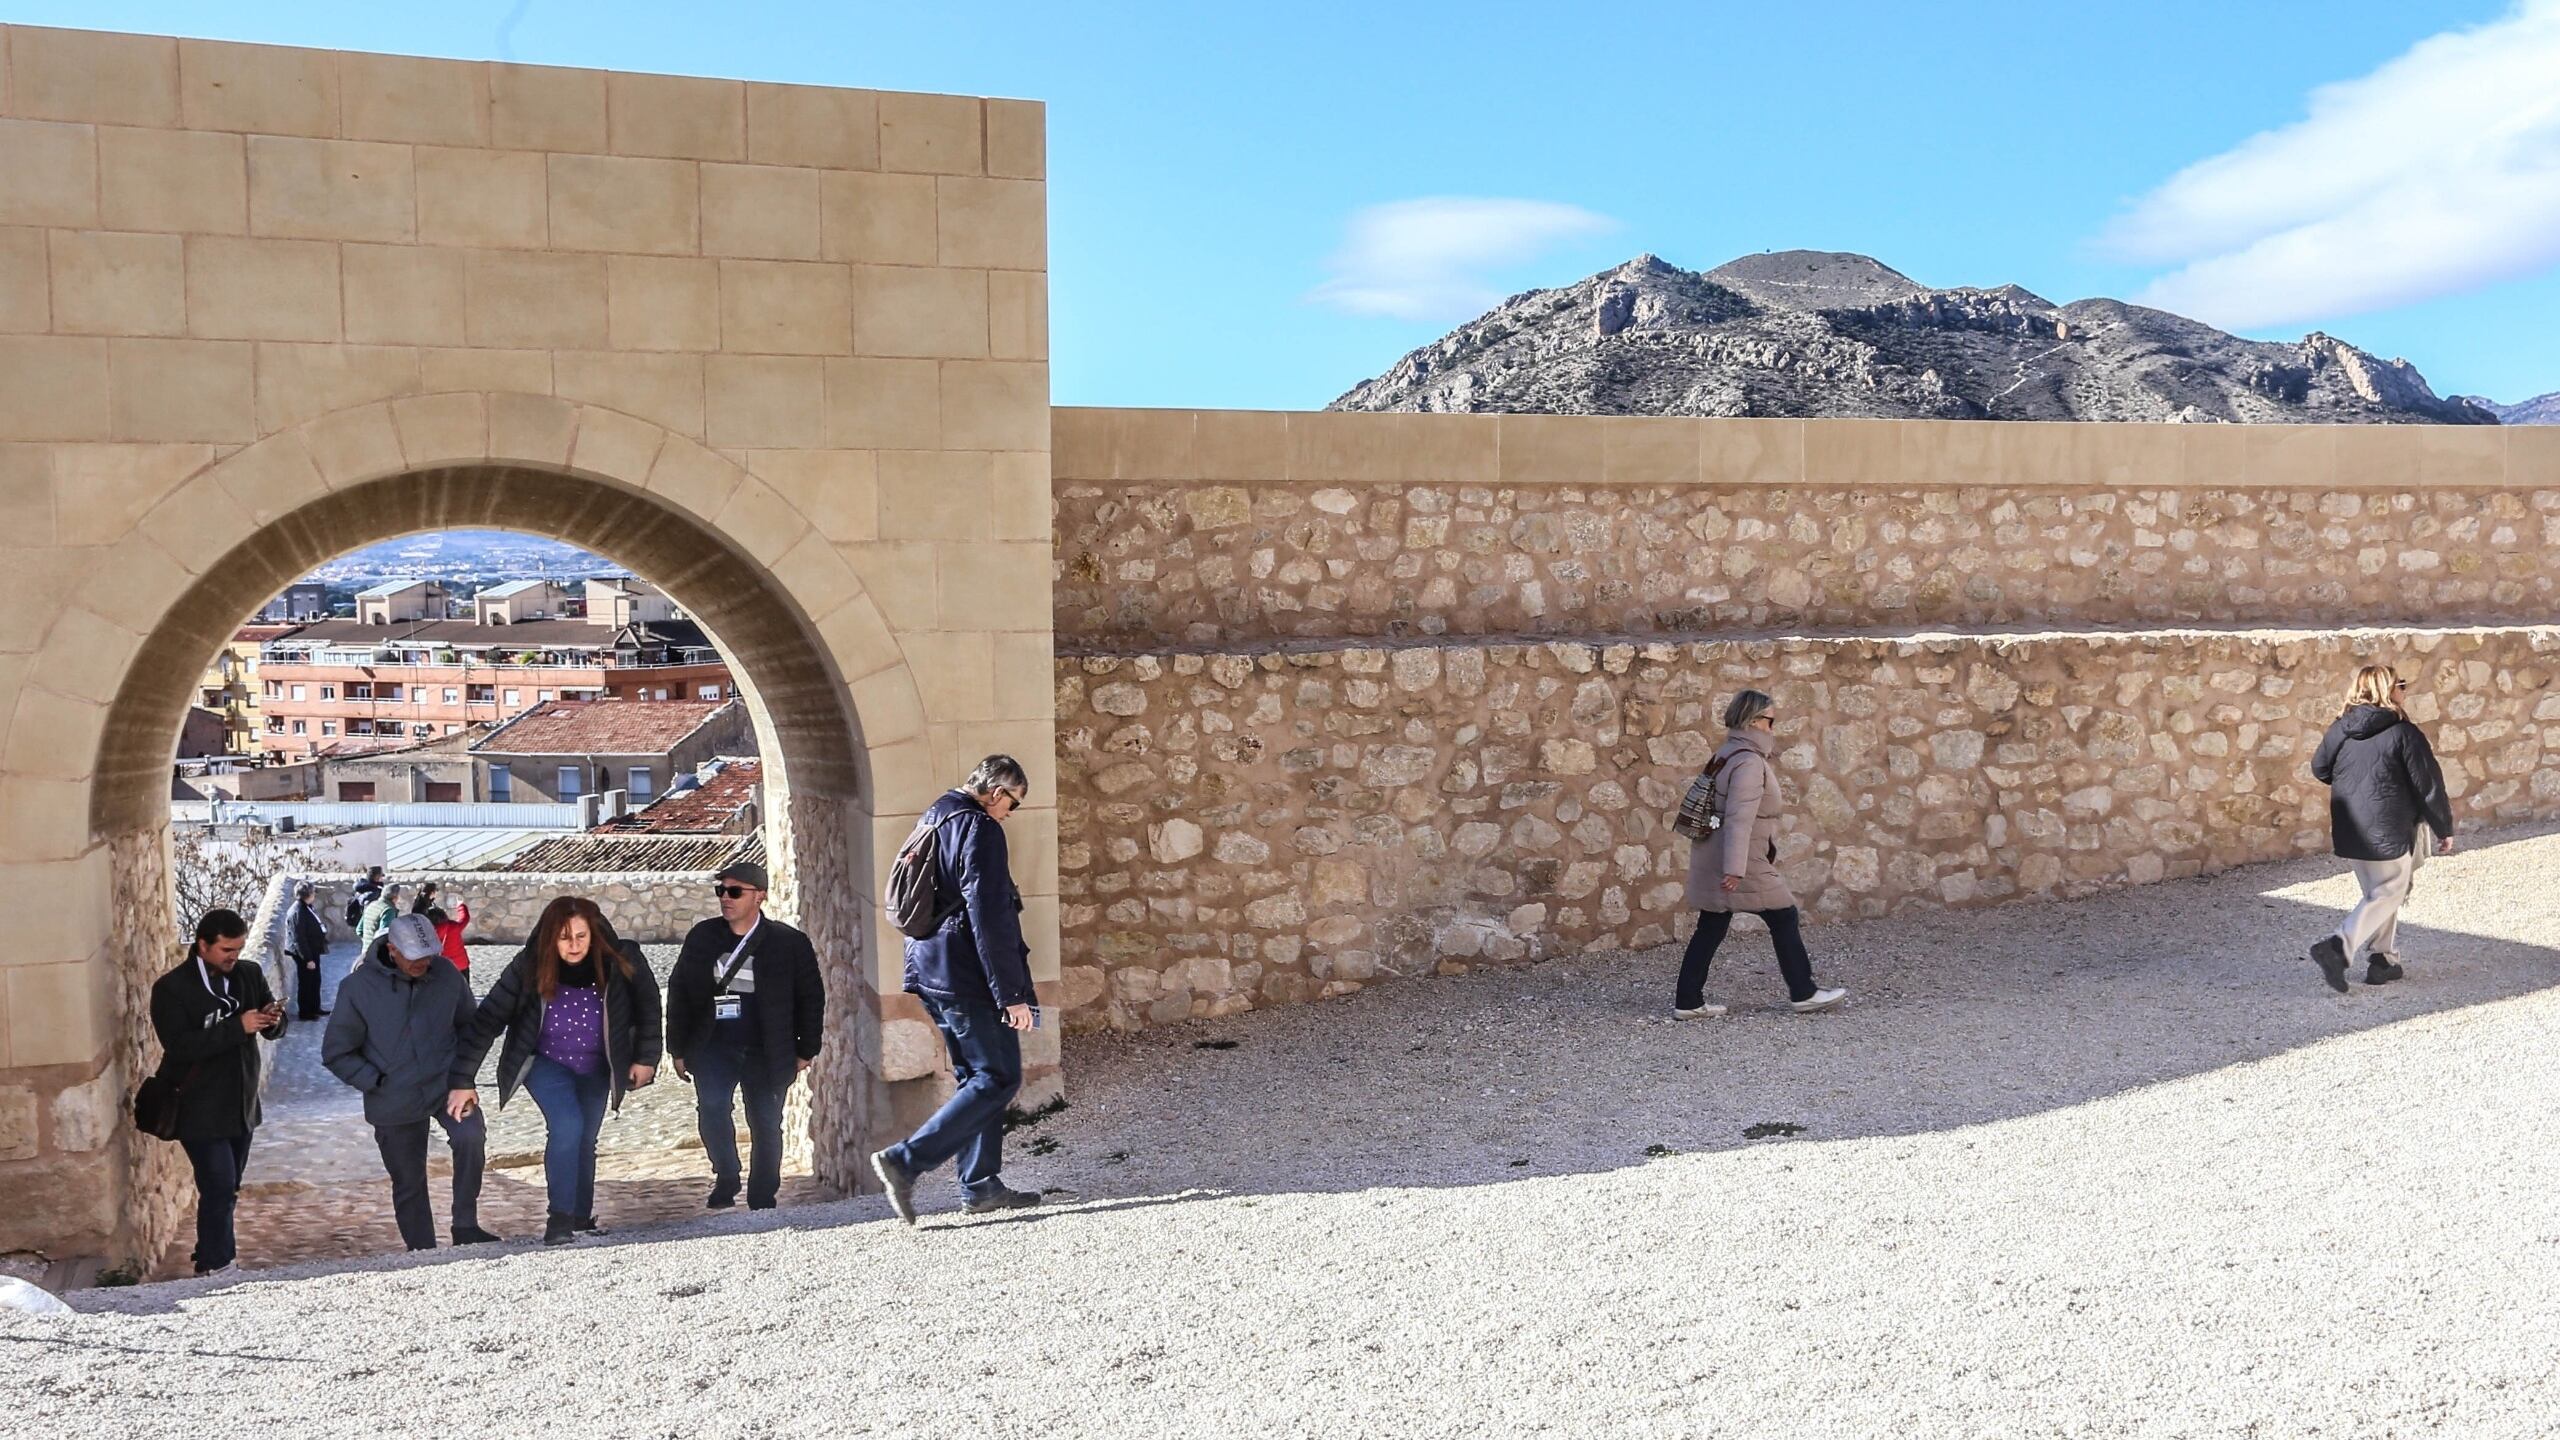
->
82;392;922;1253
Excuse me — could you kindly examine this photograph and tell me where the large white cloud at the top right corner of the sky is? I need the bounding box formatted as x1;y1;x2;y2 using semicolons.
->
2102;0;2560;328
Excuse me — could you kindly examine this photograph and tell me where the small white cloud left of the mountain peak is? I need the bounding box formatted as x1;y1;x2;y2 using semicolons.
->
1308;195;1618;320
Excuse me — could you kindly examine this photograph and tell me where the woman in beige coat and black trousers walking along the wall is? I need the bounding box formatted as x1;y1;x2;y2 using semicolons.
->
1672;689;1848;1020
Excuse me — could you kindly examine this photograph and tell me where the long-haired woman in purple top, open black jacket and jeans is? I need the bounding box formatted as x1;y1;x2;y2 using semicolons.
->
445;894;666;1245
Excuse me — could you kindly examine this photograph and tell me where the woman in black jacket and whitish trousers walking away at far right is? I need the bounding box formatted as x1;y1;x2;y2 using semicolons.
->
2312;666;2452;994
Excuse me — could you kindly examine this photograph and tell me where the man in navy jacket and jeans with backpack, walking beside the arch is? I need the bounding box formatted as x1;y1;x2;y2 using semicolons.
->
870;756;1039;1225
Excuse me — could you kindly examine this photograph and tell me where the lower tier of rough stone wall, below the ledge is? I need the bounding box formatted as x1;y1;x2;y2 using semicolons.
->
1057;628;2560;1027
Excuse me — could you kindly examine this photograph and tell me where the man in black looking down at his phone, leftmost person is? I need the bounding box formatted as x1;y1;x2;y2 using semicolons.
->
151;910;284;1276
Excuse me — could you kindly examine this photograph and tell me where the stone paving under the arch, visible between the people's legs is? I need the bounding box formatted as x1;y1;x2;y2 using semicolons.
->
212;943;835;1273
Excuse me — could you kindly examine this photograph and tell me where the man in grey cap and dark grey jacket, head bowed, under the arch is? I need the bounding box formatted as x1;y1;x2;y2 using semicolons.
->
320;915;497;1250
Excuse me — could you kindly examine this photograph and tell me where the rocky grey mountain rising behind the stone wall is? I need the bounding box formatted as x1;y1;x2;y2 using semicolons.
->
1331;251;2496;425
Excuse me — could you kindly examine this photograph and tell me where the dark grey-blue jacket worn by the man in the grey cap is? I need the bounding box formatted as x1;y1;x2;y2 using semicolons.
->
320;940;476;1125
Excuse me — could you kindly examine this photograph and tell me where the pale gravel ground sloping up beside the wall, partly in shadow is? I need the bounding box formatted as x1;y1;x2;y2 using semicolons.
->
20;830;2560;1437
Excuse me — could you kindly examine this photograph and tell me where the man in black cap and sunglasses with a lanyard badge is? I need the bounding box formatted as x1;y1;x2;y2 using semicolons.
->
666;861;827;1209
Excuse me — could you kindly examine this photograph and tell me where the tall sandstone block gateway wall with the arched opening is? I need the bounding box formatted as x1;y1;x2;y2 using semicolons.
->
0;28;1057;1261
